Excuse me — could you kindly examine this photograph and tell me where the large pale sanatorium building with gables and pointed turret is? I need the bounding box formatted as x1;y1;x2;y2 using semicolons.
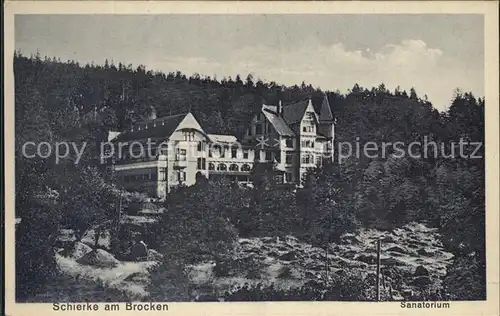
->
111;96;335;197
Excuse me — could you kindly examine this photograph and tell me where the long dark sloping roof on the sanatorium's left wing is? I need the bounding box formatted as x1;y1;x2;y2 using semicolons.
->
114;113;188;142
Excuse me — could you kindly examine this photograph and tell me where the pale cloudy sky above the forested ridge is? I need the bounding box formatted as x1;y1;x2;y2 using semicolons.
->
15;14;484;110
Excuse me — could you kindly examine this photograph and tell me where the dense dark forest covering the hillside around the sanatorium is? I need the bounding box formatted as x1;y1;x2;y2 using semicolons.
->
13;52;486;299
